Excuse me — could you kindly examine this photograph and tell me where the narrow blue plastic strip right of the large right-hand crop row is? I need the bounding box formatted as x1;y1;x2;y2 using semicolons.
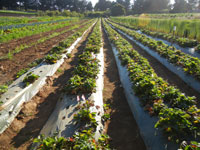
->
111;25;200;91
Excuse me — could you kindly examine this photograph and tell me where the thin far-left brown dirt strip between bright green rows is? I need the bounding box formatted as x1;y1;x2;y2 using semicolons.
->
0;20;86;56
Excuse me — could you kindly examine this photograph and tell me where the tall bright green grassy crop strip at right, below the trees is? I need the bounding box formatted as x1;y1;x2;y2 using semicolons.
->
112;17;200;41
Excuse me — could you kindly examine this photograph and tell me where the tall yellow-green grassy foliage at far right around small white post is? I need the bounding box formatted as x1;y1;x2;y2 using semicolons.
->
111;15;200;41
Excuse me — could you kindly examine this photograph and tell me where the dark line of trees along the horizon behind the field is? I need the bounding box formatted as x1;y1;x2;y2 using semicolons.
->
0;0;200;15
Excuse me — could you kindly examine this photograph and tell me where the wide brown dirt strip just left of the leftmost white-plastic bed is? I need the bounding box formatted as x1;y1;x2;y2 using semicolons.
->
0;22;89;84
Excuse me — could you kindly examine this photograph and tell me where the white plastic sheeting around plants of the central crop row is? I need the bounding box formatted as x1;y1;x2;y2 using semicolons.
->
37;28;104;141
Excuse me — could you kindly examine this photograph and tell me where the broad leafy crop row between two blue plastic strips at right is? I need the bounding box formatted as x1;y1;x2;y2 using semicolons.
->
104;19;200;147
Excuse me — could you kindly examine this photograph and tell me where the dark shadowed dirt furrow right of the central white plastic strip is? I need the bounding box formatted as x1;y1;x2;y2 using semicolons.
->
103;24;146;150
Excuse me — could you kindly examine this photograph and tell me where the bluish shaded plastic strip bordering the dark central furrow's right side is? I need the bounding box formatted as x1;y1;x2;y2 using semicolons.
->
105;27;178;150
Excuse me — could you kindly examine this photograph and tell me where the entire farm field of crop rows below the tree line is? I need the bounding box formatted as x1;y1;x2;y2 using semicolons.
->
0;14;200;150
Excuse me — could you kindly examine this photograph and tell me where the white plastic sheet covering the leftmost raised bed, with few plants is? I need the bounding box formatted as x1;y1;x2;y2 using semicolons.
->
0;23;95;134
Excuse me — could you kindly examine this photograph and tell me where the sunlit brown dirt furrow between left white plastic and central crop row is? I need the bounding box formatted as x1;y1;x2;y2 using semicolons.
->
0;22;94;150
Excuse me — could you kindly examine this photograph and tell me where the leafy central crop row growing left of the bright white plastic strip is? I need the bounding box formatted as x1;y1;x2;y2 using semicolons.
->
34;21;109;150
